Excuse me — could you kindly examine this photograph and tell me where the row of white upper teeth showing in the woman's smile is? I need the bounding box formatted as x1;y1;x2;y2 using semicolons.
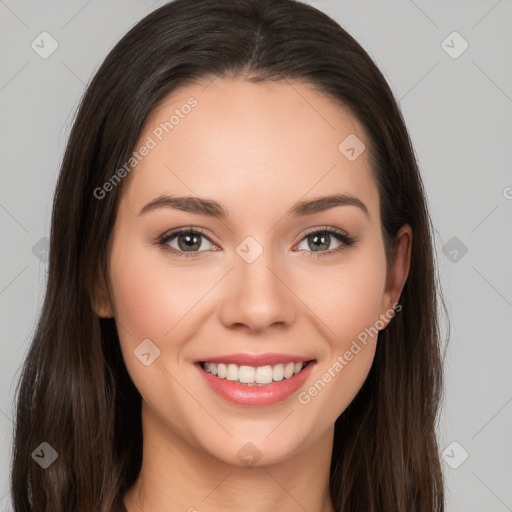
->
203;363;304;385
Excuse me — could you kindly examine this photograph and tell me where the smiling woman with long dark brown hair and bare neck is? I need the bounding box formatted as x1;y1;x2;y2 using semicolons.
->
12;0;444;512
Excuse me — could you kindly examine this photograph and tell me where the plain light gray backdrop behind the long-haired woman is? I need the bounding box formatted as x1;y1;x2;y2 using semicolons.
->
0;0;512;512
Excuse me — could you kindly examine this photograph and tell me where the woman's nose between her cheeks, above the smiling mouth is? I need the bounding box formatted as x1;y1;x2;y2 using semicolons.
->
219;251;296;332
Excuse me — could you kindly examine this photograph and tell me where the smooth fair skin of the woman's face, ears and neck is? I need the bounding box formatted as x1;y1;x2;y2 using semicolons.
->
94;77;412;512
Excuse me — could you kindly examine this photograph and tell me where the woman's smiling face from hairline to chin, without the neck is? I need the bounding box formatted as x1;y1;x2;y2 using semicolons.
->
96;79;409;465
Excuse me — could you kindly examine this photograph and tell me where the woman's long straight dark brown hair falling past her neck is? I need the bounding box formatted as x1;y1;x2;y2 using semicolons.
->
11;0;444;512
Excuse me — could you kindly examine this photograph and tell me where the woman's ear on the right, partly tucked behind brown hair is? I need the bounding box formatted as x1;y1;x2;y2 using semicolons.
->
380;224;412;325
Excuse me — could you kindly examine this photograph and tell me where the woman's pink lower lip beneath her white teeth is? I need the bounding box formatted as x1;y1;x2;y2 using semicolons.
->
196;361;315;407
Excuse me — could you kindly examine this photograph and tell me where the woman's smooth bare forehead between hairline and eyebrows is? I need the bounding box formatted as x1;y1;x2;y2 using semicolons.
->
118;78;378;218
